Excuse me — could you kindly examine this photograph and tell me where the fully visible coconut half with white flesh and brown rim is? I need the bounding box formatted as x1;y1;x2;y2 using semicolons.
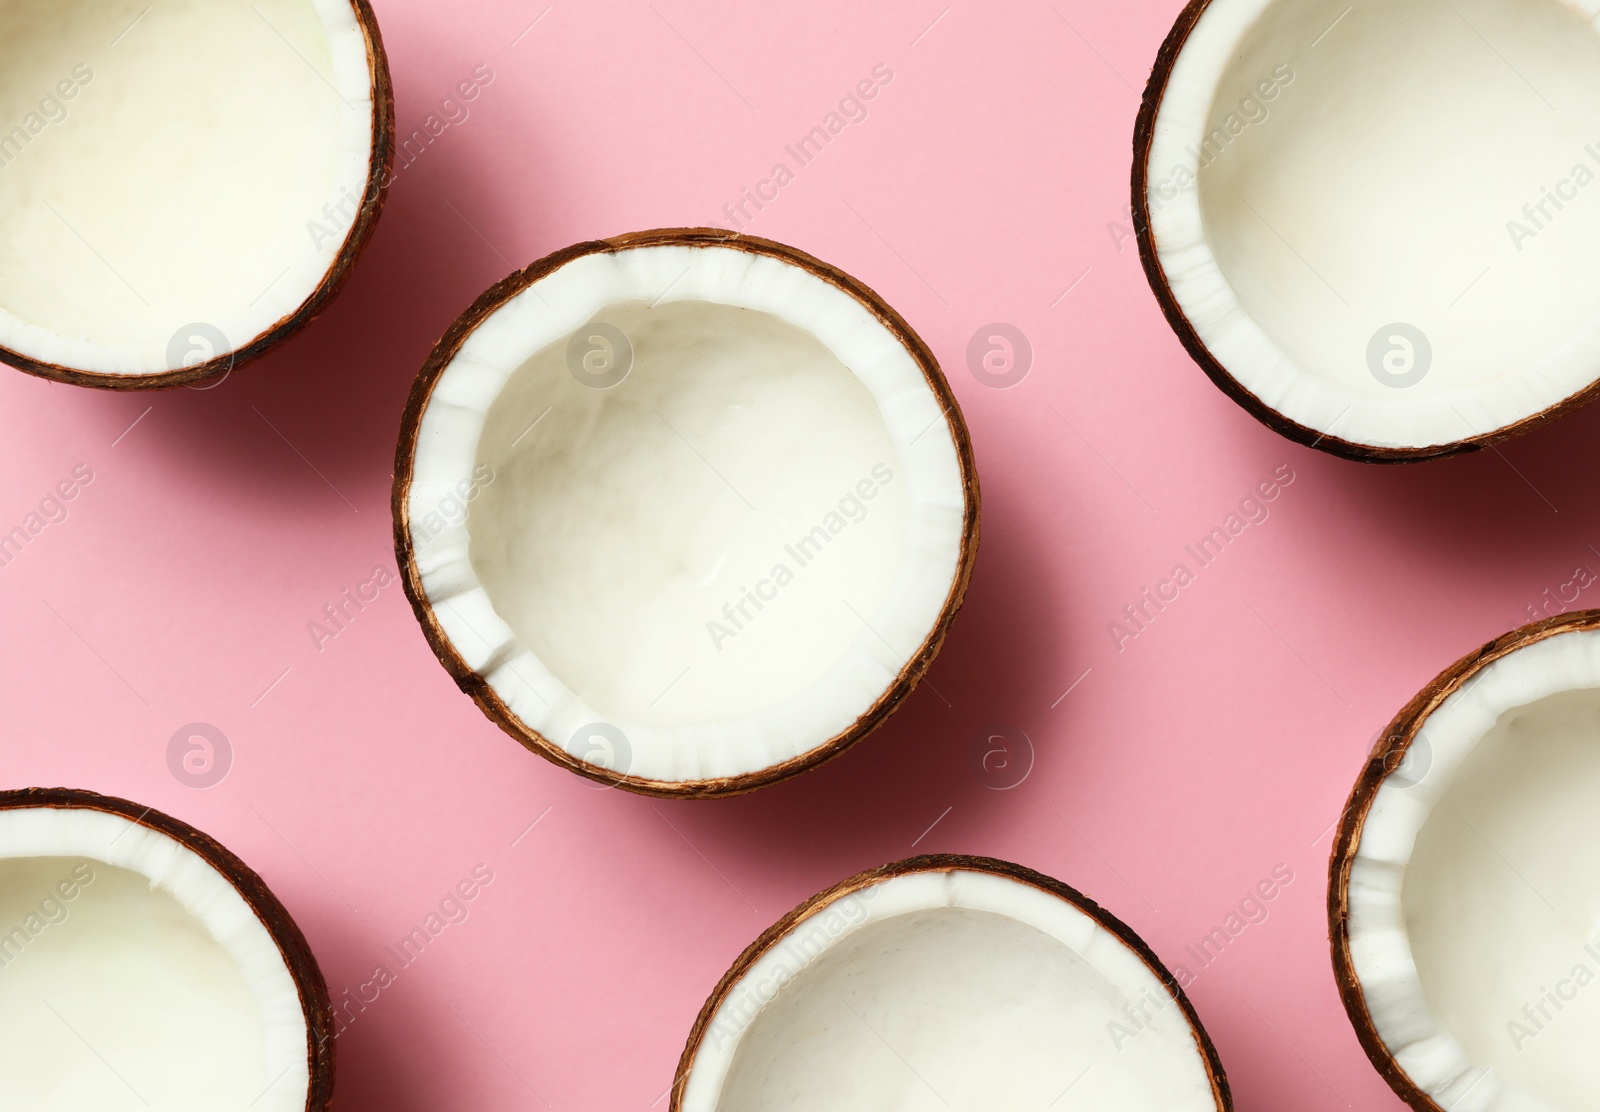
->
394;229;978;797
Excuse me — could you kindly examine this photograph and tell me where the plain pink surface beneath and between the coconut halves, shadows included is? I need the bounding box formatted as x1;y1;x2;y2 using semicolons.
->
0;0;1580;1112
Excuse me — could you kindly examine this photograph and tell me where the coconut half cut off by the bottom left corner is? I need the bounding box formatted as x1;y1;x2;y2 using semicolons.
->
0;789;333;1112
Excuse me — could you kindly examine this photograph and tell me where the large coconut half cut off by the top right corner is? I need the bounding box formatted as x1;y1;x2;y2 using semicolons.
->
1133;0;1600;461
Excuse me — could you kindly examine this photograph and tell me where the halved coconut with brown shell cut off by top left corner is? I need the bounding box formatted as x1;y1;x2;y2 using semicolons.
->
0;0;394;389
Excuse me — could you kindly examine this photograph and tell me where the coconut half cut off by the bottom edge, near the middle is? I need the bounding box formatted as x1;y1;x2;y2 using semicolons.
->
672;856;1232;1112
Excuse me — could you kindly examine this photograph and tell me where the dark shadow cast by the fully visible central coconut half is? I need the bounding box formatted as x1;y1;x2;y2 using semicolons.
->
643;470;1072;890
